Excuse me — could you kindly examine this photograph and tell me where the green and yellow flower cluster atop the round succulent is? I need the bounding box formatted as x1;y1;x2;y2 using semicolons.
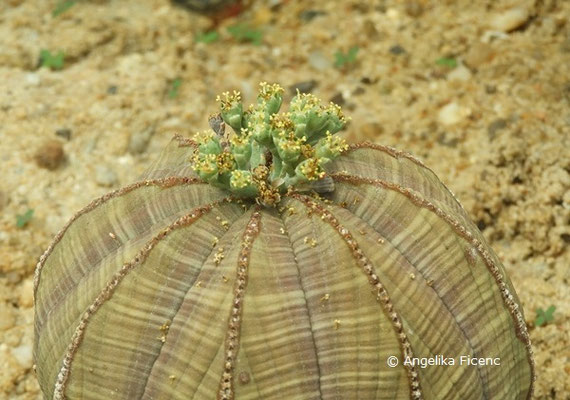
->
192;82;348;205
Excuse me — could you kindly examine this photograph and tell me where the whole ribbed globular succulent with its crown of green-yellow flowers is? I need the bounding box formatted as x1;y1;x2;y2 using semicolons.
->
34;84;534;400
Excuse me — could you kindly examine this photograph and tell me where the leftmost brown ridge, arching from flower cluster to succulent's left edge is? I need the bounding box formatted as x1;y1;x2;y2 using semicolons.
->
34;176;206;296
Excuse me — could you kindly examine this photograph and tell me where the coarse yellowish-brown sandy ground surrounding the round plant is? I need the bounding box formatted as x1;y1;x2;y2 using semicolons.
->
0;0;570;399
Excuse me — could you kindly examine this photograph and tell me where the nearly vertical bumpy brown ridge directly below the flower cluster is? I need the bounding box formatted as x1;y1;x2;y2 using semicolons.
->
218;206;261;400
